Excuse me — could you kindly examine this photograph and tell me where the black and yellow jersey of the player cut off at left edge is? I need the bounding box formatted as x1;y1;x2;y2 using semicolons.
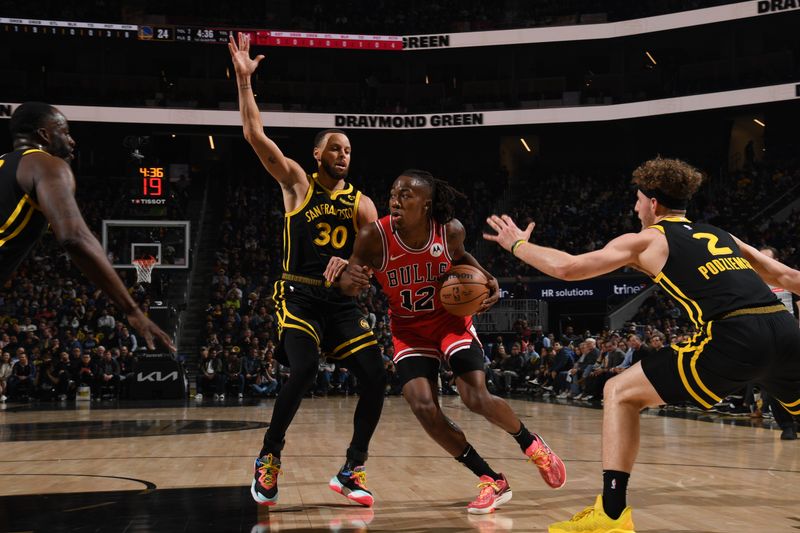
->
0;149;47;283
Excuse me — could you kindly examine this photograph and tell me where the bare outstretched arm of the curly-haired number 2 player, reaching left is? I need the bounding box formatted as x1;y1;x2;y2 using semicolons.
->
483;215;666;281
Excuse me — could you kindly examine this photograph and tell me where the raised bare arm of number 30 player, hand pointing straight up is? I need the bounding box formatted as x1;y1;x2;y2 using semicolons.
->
228;32;306;190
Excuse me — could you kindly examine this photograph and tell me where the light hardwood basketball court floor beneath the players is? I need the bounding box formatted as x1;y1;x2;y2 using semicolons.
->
0;396;800;533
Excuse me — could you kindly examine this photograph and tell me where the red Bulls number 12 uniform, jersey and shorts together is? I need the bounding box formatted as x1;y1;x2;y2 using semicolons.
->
375;216;478;362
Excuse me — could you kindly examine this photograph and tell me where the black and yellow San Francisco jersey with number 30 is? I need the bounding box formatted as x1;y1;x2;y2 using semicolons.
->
283;173;361;280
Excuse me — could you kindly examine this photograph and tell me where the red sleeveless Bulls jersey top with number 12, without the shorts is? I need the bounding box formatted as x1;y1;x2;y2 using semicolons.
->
375;216;452;324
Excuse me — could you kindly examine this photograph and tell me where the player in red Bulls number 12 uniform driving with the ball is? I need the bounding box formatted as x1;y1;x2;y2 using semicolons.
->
339;170;566;514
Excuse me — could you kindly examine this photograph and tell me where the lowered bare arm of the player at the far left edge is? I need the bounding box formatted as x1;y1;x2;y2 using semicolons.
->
26;154;175;351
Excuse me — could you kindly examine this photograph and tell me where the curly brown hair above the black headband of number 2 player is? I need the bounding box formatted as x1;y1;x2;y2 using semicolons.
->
631;156;703;200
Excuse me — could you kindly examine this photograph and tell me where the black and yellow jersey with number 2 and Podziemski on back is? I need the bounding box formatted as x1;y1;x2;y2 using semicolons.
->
650;217;778;329
